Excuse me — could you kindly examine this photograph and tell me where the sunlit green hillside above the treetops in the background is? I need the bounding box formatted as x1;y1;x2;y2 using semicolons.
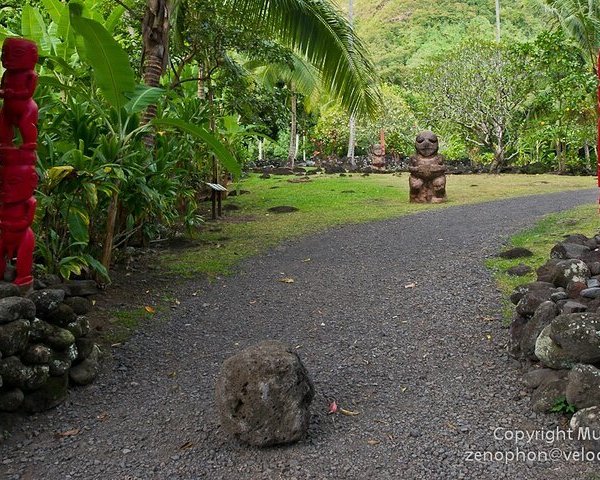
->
337;0;543;81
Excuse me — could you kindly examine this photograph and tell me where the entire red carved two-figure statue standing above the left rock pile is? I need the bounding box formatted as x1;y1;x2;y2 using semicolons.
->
0;38;38;291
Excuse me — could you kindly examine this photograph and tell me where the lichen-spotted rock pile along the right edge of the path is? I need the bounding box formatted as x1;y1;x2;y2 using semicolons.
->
509;234;600;450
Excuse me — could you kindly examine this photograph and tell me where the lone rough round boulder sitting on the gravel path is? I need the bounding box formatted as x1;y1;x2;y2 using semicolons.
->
216;341;314;447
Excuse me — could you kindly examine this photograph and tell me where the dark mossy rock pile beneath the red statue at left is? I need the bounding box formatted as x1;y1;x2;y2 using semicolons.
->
0;275;100;412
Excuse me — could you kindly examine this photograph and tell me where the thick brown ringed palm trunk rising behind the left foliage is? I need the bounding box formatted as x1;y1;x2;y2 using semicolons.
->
141;0;169;148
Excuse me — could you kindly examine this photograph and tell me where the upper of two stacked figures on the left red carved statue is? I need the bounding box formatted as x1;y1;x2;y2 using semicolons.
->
0;38;38;150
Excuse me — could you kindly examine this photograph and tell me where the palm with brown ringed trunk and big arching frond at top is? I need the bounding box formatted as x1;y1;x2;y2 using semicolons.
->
142;0;379;144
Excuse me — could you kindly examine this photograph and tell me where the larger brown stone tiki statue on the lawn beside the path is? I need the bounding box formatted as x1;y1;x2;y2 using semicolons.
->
409;131;446;203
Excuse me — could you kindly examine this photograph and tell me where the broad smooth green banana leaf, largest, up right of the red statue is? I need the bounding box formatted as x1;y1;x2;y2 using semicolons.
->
69;3;135;111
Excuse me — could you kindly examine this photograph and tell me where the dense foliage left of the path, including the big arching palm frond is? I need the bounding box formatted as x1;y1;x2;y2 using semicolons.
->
0;0;379;278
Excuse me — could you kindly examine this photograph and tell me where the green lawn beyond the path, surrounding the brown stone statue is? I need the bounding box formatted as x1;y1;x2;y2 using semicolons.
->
163;173;596;277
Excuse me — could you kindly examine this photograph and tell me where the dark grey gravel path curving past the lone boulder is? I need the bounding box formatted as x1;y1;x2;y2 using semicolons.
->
0;190;598;480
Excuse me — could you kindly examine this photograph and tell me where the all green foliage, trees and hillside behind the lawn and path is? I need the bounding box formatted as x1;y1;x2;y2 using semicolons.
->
0;0;600;278
